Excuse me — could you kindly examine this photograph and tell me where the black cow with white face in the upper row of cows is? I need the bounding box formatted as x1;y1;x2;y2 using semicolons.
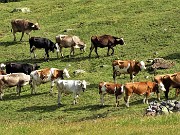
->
29;37;59;61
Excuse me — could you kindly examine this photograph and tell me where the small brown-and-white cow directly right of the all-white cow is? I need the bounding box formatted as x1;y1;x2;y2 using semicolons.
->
99;82;123;107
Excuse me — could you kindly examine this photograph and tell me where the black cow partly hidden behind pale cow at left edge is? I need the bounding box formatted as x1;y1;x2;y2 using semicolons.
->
6;63;40;75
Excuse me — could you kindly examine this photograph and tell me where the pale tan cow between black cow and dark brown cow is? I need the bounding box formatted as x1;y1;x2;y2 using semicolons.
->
55;35;86;57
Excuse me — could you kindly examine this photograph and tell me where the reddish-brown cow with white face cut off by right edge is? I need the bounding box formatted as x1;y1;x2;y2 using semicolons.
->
154;72;180;100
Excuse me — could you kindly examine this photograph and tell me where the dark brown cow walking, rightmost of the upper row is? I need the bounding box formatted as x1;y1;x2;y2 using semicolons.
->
89;35;125;57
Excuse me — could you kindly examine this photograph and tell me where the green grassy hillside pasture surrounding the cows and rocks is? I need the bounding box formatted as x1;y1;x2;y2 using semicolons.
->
0;0;180;135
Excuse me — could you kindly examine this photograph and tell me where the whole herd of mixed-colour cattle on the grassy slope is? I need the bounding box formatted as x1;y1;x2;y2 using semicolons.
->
0;19;180;107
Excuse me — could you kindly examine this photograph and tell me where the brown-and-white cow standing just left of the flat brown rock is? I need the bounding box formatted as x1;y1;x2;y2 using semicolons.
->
112;60;146;82
